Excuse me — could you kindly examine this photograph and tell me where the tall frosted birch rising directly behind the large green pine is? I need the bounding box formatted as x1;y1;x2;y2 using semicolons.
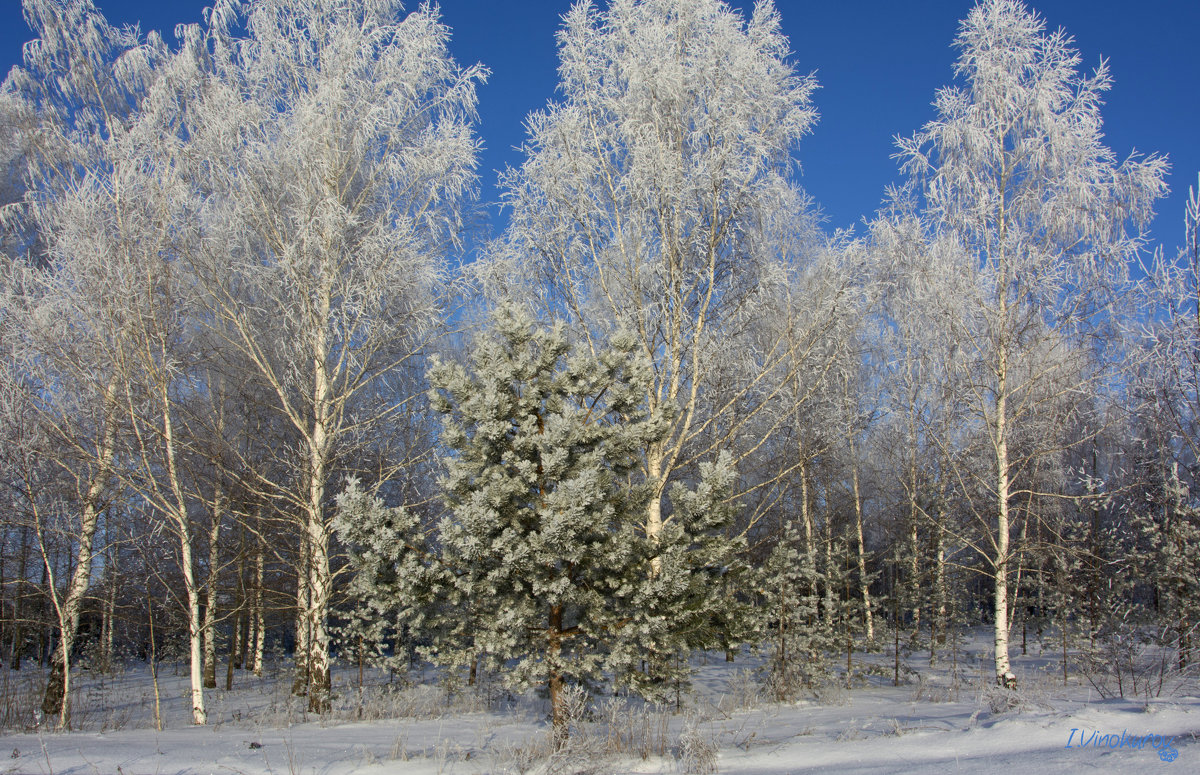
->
492;0;816;561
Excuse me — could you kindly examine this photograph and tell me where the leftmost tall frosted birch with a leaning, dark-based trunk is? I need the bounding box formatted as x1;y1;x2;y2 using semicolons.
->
4;0;171;720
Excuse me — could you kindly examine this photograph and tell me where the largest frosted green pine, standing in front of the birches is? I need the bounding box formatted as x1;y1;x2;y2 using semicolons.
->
430;306;665;743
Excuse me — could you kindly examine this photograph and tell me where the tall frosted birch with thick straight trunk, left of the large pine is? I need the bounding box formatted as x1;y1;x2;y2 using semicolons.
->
180;0;482;710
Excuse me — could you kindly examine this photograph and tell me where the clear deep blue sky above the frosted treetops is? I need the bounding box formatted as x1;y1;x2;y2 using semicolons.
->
0;0;1200;252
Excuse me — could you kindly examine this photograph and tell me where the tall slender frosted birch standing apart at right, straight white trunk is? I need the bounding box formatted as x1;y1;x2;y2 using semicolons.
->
899;0;1165;686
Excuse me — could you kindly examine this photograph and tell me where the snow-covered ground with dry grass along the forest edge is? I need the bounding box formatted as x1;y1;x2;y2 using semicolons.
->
0;632;1200;775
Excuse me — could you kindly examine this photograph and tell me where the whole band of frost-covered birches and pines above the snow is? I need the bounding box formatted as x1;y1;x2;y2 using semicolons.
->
0;0;1200;740
